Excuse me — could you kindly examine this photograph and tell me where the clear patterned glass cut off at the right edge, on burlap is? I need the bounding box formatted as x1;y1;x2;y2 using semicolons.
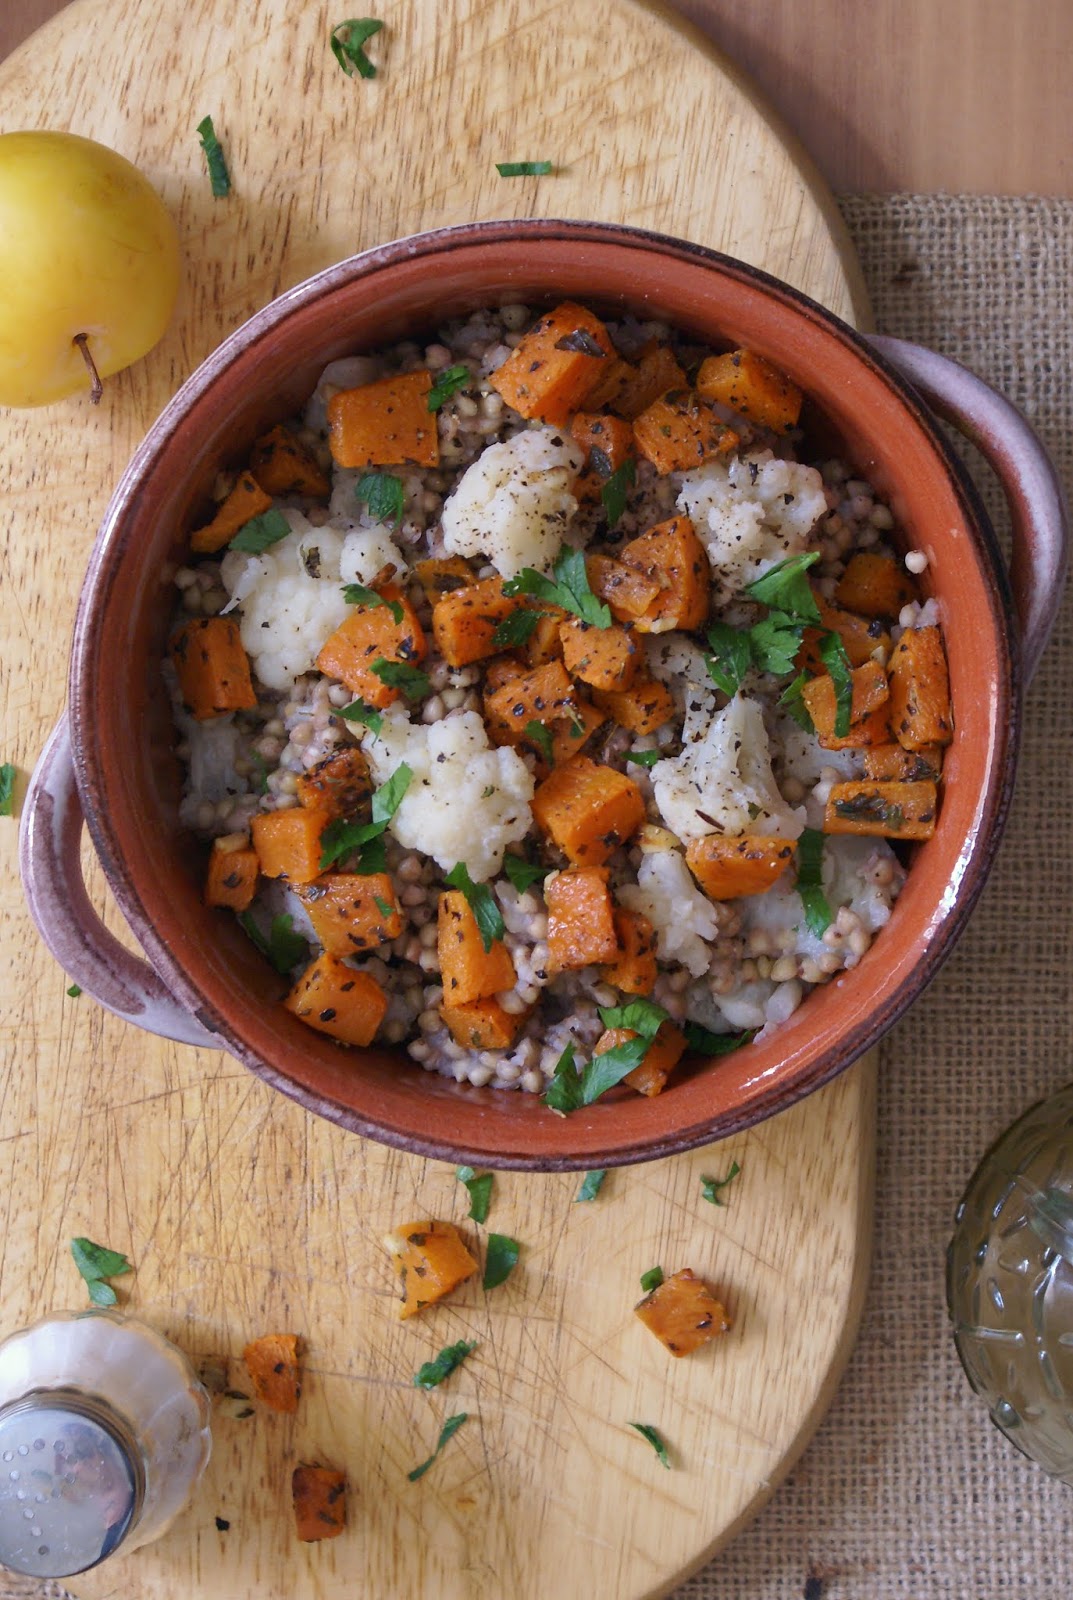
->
947;1085;1073;1486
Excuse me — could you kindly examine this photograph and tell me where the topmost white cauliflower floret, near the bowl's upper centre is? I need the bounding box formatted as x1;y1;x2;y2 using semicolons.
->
443;427;585;578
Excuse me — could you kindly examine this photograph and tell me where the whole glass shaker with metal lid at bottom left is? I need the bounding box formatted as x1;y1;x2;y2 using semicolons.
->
0;1309;211;1578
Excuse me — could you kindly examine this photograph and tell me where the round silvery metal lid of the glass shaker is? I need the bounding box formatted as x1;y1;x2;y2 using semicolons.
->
0;1389;146;1578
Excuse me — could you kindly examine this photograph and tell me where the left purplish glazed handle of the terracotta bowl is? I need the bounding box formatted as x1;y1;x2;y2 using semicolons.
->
19;714;222;1050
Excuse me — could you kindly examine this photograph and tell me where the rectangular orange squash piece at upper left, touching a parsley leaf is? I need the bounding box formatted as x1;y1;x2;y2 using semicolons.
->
328;371;440;467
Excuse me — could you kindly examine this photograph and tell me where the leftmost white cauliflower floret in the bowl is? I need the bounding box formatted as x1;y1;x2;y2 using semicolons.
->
221;507;350;690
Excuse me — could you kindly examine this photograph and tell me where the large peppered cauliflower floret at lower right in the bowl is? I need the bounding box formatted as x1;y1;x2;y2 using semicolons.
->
651;694;804;840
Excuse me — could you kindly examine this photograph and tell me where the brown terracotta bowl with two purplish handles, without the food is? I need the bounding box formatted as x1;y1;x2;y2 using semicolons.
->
22;222;1063;1170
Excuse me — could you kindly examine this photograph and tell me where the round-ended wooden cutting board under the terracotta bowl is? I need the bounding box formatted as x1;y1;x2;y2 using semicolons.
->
0;0;873;1600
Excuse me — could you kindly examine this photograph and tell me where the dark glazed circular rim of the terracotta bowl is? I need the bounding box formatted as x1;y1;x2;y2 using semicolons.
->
69;218;1022;1171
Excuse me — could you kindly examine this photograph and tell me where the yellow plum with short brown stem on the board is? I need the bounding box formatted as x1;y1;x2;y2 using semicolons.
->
0;131;179;406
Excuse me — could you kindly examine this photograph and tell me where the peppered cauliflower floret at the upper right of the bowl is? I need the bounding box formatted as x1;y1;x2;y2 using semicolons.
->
678;450;827;606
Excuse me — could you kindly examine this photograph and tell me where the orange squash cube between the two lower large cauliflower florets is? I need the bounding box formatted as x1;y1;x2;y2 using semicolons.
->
533;755;644;867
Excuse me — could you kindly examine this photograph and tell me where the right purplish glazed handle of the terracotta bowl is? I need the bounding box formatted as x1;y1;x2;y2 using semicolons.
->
865;334;1070;683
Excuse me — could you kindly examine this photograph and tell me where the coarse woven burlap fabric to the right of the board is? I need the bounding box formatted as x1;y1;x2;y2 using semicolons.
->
0;195;1073;1600
